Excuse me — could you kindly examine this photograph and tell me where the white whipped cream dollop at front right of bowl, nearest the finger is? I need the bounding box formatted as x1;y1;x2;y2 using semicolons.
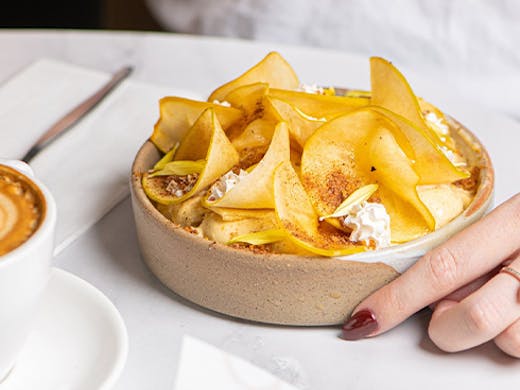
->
342;202;390;249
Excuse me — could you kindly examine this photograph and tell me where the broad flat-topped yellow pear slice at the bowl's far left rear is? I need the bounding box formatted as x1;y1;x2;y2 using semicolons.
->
150;96;243;153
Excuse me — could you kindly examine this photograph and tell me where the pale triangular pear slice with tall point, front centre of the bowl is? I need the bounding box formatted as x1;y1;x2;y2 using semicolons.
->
207;122;290;209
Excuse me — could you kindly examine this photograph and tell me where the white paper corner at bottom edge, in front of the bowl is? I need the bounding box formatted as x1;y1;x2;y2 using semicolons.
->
175;336;297;390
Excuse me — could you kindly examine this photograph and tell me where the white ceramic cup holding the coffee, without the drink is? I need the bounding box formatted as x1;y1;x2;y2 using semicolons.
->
0;159;56;382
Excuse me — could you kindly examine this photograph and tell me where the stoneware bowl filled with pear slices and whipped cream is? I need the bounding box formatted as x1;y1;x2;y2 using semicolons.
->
131;53;494;325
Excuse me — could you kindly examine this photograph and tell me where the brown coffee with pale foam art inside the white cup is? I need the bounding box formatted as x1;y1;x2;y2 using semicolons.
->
0;165;45;256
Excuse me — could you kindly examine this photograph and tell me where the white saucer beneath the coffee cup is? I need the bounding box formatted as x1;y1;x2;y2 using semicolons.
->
0;268;128;390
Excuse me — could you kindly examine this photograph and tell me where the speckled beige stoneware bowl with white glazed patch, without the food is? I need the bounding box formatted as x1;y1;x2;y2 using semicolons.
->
131;121;494;326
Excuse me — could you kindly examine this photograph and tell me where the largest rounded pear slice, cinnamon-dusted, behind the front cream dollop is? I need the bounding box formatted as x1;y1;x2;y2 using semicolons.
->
302;109;435;239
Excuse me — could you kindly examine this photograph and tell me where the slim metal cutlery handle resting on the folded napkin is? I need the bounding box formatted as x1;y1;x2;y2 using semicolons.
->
21;66;133;163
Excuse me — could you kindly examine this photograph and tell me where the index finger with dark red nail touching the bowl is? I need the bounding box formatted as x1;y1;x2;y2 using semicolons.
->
343;194;520;339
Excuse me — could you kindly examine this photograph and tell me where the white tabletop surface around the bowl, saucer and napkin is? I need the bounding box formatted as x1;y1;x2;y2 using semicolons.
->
0;30;520;390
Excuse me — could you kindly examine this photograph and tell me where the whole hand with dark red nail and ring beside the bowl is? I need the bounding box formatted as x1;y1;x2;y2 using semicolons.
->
343;194;520;358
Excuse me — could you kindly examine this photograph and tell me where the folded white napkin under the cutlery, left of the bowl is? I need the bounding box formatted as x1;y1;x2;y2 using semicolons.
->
0;59;195;253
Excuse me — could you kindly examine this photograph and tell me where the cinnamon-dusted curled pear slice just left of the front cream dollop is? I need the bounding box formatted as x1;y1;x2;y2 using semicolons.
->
274;161;366;256
